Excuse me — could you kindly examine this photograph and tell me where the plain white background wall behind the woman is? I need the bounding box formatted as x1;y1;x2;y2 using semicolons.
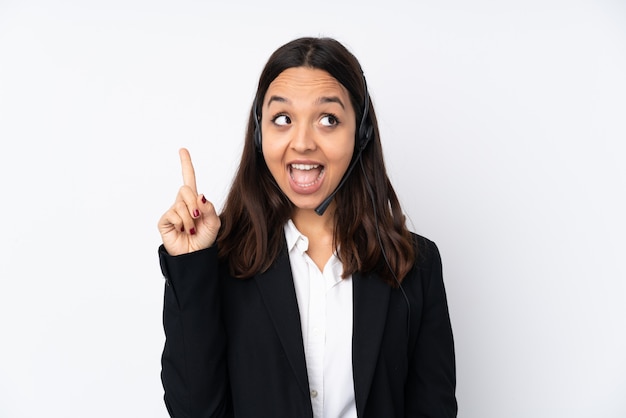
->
0;0;626;418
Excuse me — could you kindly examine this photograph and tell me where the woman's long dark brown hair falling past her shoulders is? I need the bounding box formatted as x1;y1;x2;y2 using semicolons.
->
218;38;416;286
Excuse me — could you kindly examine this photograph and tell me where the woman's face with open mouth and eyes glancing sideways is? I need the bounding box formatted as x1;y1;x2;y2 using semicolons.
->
261;67;356;214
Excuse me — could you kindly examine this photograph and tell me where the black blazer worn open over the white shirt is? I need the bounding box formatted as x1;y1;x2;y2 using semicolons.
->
159;235;457;418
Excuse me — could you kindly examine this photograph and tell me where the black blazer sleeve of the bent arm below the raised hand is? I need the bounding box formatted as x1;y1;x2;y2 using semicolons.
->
159;245;232;418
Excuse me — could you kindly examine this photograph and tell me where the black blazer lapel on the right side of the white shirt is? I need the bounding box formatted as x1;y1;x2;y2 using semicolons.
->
352;273;391;417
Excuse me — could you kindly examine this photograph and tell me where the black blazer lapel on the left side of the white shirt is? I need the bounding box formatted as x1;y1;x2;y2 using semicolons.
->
255;245;309;396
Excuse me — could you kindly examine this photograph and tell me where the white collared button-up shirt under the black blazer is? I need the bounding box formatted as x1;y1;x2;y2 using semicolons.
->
284;220;356;418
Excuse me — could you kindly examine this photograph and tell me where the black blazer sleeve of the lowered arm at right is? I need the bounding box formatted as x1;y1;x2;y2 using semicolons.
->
405;239;458;418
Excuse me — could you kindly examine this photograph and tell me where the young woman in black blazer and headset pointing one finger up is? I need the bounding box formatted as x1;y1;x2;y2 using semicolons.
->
158;38;457;418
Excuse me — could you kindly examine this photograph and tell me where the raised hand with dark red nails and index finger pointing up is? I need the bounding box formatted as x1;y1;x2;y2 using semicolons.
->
158;148;221;255
